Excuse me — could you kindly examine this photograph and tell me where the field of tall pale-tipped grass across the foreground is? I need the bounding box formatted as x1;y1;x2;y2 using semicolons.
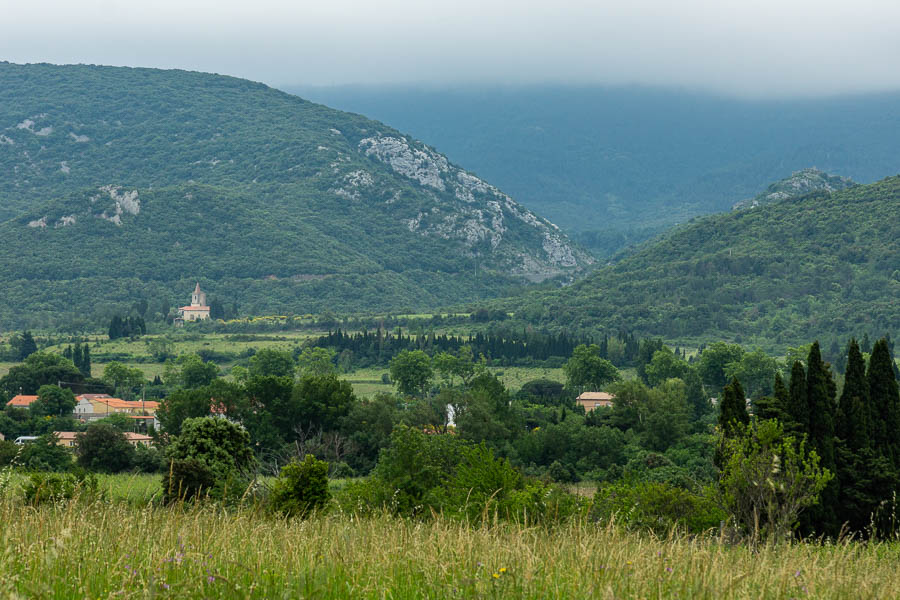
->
0;498;900;599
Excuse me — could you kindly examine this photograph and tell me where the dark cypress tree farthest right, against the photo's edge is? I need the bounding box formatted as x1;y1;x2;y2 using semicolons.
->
866;338;900;468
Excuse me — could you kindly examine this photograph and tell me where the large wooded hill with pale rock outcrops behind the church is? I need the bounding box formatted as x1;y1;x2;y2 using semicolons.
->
0;63;591;327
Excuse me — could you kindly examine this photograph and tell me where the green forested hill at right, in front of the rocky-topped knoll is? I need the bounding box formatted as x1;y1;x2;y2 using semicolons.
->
507;177;900;349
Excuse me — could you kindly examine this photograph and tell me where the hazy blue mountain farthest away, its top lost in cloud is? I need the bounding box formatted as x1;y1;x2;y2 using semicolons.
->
298;85;900;255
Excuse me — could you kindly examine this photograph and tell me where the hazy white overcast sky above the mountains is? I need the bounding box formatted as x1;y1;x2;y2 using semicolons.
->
0;0;900;96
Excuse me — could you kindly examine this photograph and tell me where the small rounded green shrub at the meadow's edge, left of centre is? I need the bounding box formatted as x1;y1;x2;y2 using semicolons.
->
270;454;331;517
